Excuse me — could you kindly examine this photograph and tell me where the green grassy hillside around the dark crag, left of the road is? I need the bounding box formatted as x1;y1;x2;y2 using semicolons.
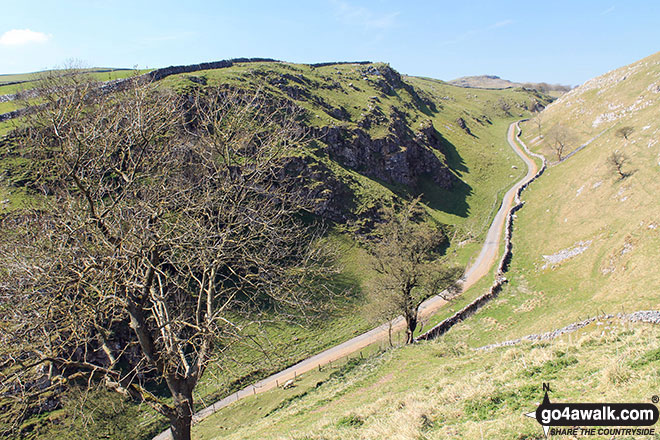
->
0;63;547;439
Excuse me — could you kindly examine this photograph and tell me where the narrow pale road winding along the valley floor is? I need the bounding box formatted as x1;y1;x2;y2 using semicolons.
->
154;118;538;440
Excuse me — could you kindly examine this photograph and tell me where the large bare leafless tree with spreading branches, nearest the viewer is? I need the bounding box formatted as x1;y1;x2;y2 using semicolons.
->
0;72;334;440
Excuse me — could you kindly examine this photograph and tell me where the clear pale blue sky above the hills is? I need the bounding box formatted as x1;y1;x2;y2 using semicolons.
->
0;0;660;85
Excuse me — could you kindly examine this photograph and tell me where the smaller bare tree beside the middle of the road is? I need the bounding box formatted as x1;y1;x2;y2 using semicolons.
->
369;199;463;344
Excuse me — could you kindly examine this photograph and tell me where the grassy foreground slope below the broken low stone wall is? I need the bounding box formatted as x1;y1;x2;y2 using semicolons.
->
194;319;660;440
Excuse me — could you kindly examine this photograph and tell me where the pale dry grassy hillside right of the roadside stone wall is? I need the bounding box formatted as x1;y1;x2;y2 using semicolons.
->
436;54;660;345
